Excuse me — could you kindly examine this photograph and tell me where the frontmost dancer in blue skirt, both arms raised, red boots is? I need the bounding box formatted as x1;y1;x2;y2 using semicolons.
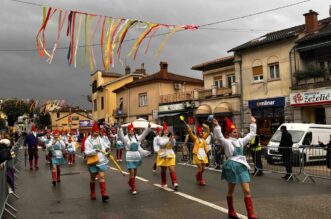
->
213;117;257;219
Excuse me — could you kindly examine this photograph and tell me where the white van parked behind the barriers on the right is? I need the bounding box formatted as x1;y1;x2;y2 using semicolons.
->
266;123;331;165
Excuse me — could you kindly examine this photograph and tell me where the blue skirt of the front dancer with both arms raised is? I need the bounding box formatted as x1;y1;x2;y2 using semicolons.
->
221;160;251;184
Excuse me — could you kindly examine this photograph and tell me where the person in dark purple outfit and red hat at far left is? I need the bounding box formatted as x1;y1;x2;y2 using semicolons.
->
23;124;45;170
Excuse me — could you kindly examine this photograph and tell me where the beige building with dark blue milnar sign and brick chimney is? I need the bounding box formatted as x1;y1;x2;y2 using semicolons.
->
230;11;331;144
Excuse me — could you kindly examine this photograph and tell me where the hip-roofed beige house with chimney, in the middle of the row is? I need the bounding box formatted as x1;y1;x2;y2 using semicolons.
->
114;62;203;129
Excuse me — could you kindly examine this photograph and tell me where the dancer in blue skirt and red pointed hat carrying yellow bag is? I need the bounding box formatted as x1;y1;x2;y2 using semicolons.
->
85;122;110;202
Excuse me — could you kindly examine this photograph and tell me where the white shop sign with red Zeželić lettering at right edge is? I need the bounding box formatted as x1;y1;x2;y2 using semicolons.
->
290;89;331;106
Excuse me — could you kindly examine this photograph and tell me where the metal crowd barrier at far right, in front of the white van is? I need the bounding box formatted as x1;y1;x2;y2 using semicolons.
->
301;145;331;182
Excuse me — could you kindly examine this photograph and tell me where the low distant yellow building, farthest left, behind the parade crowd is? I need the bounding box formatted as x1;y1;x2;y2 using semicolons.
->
49;107;92;131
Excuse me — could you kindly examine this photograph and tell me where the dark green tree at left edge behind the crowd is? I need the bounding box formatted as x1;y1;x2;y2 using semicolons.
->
1;99;31;126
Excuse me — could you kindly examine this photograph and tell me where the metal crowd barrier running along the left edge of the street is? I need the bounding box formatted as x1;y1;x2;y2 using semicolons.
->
0;138;22;218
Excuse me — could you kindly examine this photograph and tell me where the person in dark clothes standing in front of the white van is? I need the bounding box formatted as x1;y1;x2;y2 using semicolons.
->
279;125;293;180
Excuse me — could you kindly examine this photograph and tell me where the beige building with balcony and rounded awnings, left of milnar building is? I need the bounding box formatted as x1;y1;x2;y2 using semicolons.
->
192;56;240;130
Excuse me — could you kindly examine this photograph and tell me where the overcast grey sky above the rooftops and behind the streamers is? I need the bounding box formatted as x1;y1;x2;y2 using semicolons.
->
0;0;331;107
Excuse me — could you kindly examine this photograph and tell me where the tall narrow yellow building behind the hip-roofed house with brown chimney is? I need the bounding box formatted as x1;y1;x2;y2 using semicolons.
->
91;65;145;124
